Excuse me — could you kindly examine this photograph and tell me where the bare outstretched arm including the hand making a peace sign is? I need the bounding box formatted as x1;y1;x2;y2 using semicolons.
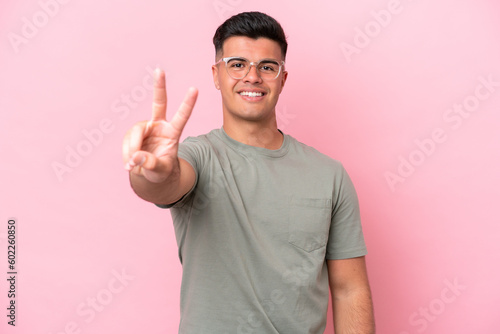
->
123;70;198;204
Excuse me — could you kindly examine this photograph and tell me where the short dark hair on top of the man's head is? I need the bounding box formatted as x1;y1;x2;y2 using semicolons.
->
213;12;288;59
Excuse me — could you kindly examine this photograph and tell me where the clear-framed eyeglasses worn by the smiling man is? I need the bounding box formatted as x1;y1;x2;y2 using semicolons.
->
215;57;285;80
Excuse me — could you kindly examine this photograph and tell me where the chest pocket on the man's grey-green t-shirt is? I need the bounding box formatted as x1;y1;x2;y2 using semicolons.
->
288;197;332;252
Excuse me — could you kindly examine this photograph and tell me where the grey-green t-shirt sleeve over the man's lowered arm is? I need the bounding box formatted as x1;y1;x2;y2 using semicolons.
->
326;166;367;260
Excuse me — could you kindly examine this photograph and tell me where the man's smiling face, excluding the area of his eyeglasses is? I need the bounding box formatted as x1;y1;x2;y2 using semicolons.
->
212;36;288;122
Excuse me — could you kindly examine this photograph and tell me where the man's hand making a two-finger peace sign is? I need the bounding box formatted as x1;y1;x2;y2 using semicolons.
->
123;69;198;183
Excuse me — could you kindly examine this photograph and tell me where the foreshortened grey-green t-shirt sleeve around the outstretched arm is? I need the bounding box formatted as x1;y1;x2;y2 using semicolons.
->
155;137;204;209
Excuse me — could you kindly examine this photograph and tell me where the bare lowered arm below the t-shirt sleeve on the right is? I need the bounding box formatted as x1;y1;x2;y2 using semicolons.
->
327;256;375;334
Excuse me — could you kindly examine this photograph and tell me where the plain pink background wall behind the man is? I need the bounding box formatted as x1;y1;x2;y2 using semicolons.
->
0;0;500;334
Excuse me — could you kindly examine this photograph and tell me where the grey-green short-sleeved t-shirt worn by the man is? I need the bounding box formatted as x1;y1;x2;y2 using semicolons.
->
159;129;366;334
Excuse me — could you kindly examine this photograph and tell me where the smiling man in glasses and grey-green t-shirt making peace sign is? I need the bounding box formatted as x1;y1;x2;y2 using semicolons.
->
123;12;375;334
